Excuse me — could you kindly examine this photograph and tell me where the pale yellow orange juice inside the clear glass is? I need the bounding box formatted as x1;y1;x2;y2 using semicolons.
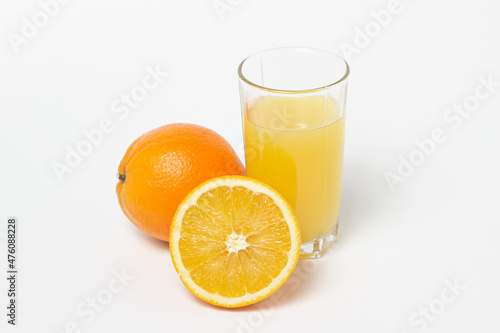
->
244;95;345;243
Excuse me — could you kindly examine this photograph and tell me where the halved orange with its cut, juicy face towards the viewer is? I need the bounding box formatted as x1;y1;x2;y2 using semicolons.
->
170;176;300;307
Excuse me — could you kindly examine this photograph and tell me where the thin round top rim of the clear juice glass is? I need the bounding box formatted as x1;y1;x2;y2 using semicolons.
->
238;46;351;94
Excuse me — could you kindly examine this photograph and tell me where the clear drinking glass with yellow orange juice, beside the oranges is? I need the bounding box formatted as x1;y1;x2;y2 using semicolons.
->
238;47;349;258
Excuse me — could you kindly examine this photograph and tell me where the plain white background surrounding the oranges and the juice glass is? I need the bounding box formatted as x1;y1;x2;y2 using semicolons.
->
0;0;500;333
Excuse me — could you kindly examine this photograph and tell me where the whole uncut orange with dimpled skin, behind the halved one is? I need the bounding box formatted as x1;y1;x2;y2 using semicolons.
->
116;124;245;242
